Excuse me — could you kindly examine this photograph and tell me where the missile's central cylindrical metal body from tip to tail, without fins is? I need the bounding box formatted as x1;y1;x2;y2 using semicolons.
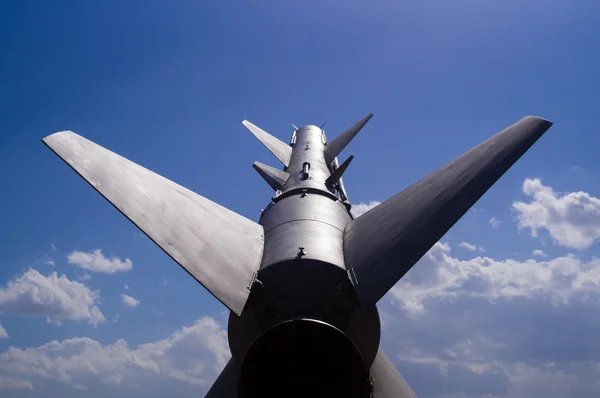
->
228;125;380;394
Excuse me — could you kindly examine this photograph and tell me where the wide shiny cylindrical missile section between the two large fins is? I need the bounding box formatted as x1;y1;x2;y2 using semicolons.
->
258;192;351;302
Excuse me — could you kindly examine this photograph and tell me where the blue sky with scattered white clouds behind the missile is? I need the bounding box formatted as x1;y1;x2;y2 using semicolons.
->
0;0;600;398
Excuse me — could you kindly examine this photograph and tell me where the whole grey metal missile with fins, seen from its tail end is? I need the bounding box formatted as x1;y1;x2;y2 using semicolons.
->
42;114;552;398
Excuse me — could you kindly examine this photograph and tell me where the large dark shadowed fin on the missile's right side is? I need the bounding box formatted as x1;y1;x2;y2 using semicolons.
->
344;116;552;306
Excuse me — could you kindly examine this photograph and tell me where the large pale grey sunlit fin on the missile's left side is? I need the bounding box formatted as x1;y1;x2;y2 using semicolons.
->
43;131;264;315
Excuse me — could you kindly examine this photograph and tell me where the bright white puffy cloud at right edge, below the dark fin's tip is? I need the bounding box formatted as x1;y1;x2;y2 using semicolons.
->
512;178;600;250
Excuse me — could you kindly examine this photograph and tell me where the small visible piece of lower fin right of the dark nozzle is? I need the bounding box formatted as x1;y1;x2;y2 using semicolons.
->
369;350;417;398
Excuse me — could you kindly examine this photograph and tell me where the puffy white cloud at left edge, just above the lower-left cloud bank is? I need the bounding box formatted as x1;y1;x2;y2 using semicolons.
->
0;268;105;326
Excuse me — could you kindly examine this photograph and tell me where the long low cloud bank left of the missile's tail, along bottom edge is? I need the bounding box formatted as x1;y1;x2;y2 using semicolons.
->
0;317;230;395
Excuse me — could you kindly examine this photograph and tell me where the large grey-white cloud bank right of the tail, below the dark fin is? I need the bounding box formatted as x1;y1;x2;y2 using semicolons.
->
379;242;600;398
